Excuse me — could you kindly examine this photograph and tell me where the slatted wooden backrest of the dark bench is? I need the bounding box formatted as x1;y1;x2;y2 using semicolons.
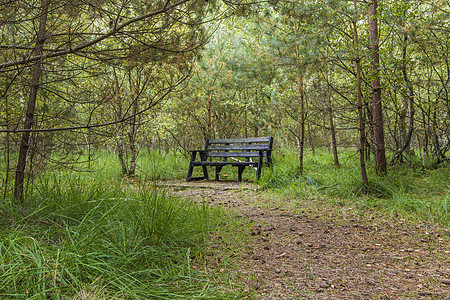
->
205;137;273;163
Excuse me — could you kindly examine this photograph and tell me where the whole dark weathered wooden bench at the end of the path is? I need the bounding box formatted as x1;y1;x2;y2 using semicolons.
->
186;137;273;182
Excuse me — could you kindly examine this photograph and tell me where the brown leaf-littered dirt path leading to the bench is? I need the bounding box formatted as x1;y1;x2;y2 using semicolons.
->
165;181;450;299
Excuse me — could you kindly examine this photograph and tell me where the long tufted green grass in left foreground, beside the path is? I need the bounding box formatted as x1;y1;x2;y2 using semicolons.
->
0;168;221;299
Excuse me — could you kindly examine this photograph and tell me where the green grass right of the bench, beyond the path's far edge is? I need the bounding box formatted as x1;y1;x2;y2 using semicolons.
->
260;149;450;226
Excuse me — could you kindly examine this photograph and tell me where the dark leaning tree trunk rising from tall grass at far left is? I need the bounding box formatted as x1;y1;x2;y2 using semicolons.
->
14;0;50;202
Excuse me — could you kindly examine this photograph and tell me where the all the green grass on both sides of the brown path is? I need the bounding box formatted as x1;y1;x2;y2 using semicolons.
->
0;149;450;299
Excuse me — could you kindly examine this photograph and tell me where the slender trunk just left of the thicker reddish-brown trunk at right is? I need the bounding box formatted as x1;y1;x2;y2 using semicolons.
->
353;0;369;187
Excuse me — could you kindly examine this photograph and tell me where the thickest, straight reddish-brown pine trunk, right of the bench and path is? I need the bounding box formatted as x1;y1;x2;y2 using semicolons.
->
369;0;387;174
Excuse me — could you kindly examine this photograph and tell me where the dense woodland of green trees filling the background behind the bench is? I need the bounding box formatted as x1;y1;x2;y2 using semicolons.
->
0;0;450;200
